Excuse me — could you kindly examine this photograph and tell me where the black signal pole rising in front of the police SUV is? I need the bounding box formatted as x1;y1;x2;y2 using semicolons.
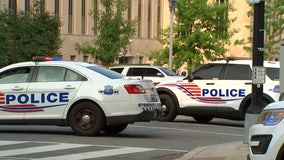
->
244;1;265;143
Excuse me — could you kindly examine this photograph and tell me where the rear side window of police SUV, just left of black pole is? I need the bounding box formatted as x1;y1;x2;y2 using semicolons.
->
222;64;252;80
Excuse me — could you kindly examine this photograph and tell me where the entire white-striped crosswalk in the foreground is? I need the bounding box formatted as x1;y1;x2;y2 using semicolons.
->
0;141;187;160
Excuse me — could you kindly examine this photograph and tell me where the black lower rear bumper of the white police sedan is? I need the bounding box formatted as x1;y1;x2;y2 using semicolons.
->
106;110;160;125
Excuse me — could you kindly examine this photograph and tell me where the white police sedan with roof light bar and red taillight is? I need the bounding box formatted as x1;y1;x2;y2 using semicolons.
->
0;57;161;136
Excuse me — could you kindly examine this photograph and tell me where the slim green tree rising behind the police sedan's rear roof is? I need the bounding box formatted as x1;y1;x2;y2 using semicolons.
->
75;0;136;66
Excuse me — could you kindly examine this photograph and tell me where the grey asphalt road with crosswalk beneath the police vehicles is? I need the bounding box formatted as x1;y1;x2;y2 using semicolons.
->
0;116;244;160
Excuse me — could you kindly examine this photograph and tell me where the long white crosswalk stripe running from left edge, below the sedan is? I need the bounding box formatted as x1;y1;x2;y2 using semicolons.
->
0;141;91;157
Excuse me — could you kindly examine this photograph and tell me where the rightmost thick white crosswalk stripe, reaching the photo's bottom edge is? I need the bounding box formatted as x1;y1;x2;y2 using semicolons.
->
38;147;154;160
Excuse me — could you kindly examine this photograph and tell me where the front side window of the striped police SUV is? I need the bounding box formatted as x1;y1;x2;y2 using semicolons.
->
193;64;224;80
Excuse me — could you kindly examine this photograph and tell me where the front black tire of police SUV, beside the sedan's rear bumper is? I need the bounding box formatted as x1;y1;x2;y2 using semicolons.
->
158;94;178;122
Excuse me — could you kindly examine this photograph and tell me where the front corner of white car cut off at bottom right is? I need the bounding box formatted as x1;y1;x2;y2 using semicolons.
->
249;101;284;160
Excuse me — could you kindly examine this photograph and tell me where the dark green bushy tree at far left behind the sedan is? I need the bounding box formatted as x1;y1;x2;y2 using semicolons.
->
0;1;62;67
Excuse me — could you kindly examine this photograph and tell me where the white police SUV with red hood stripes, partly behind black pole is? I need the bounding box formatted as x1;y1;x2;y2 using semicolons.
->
156;58;280;122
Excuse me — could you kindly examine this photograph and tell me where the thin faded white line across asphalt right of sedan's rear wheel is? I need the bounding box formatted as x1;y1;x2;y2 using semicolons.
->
130;125;244;137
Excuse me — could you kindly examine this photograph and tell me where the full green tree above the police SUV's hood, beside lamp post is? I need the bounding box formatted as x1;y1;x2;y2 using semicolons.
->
152;0;237;70
